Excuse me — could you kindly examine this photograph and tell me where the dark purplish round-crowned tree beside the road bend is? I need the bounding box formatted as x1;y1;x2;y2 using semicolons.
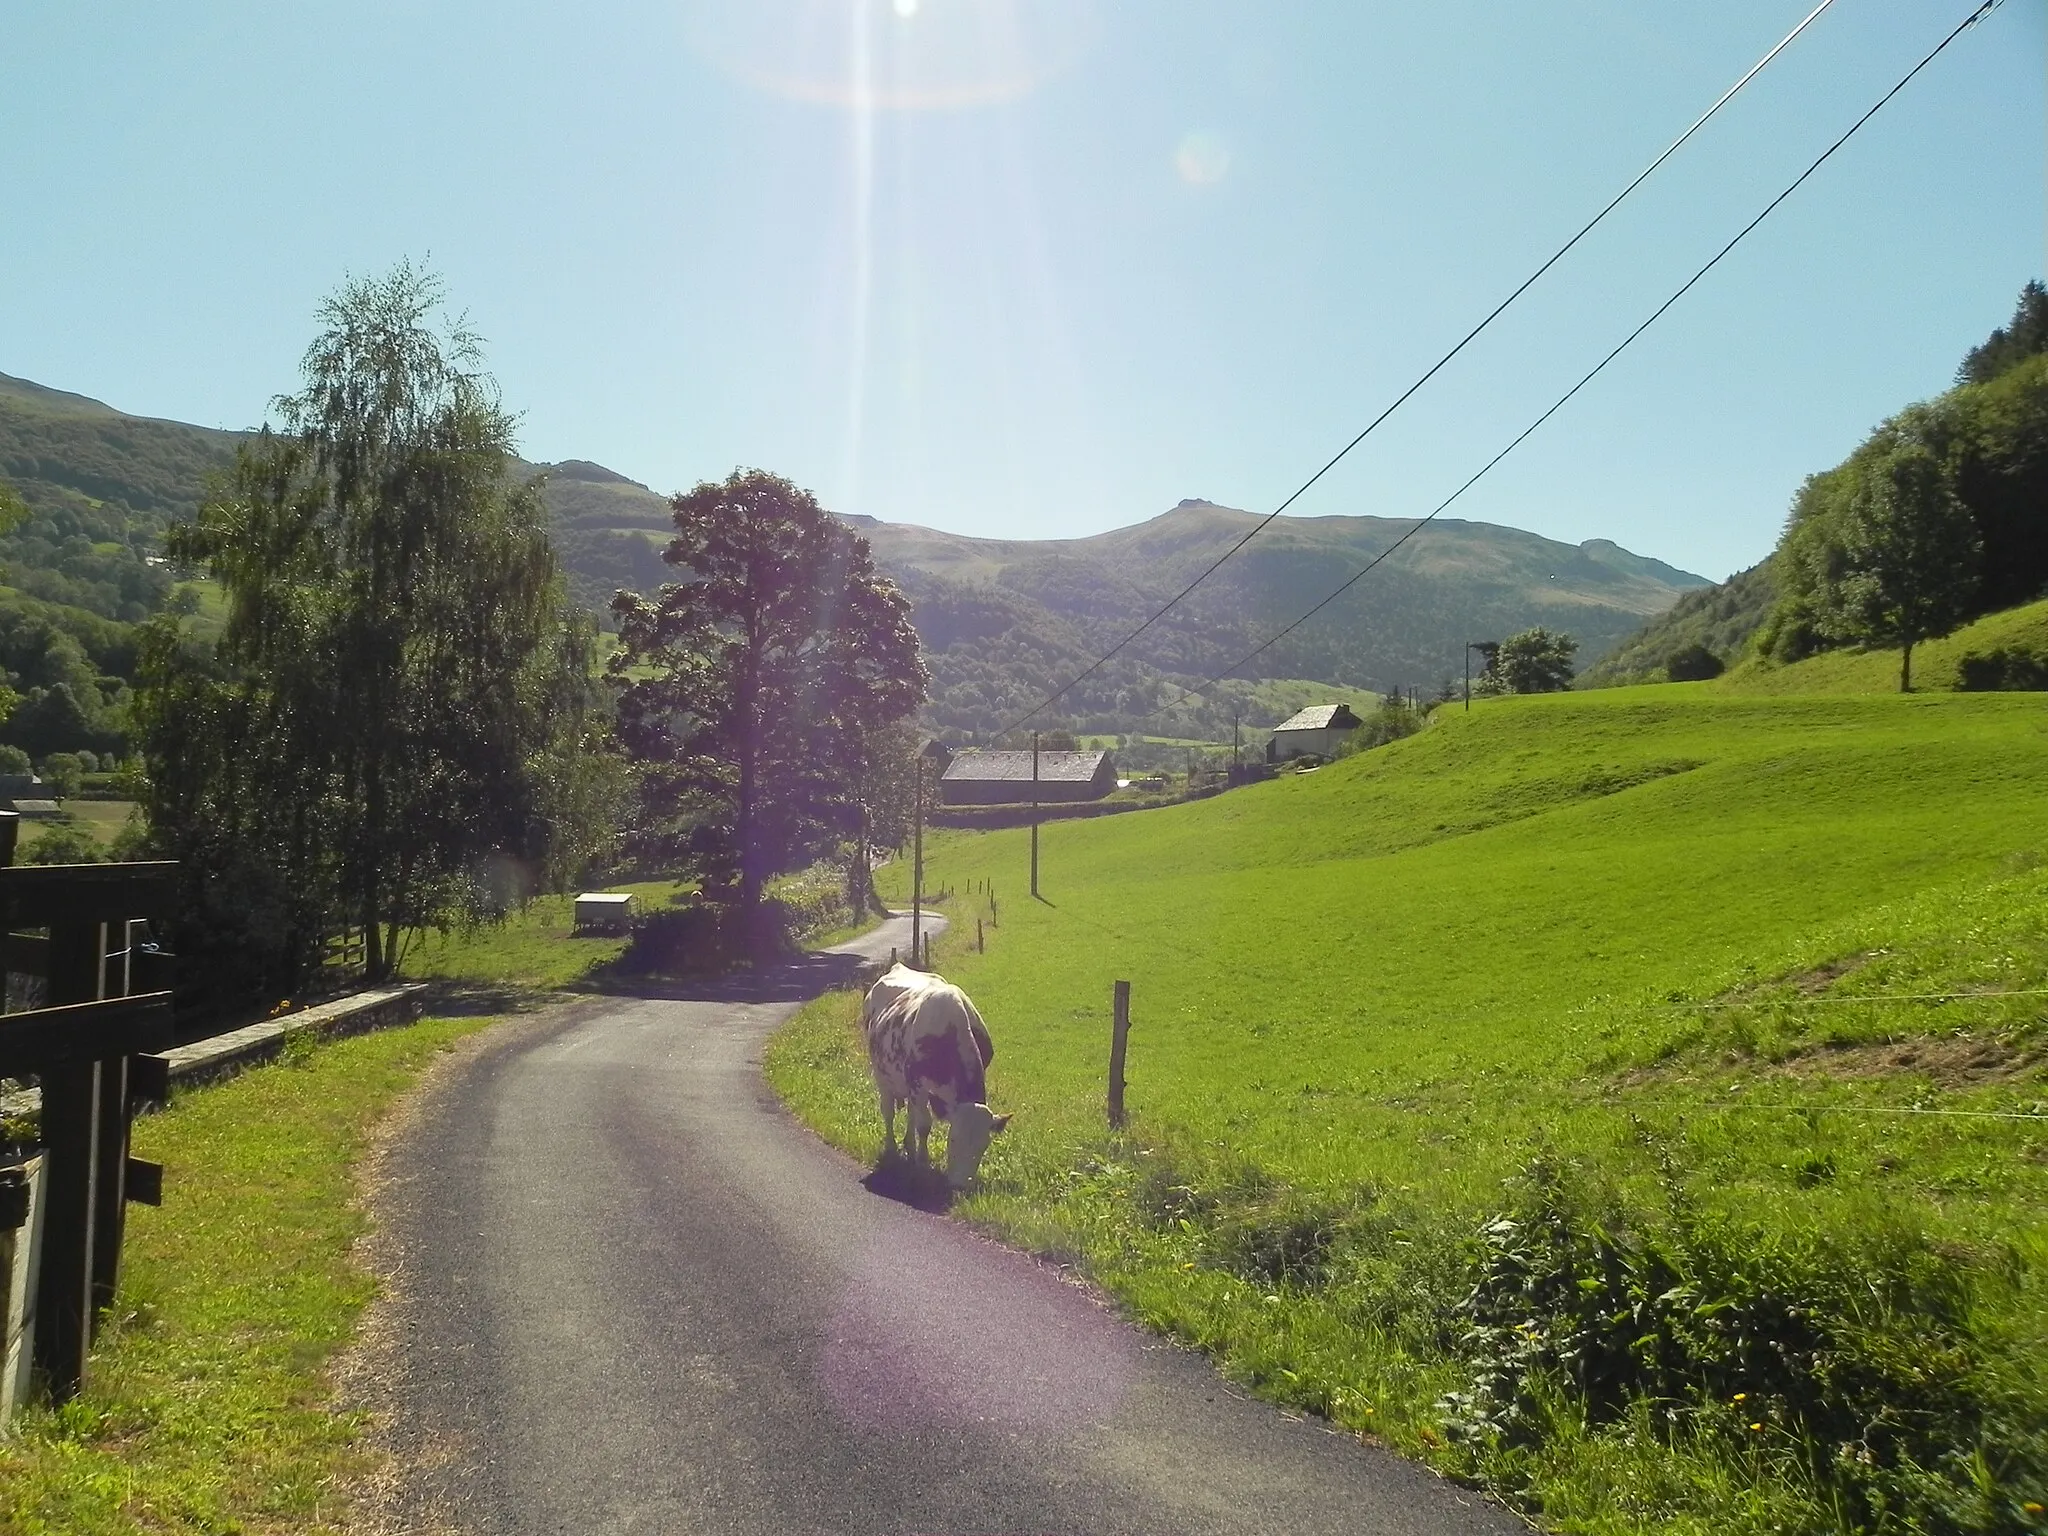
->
610;469;928;946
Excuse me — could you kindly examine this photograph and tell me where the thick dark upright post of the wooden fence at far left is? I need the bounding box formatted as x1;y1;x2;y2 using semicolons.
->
35;922;102;1403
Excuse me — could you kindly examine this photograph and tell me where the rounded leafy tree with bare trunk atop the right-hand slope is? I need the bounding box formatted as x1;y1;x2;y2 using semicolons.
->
1786;438;1982;692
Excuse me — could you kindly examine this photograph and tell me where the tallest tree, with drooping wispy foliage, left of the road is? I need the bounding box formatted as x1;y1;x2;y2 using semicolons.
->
137;266;596;979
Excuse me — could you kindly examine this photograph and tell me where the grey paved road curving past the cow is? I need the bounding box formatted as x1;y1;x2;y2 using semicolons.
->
379;926;1522;1536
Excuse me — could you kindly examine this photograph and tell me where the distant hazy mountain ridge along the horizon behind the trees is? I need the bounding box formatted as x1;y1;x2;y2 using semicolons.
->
0;375;1706;739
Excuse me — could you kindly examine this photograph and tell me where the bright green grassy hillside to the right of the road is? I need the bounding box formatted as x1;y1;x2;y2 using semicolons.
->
772;684;2048;1532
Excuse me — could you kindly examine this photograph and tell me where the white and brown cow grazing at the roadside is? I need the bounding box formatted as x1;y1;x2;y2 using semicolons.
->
860;965;1010;1190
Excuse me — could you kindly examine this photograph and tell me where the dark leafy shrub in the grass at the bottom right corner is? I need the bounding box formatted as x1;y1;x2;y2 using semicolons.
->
1444;1165;2048;1536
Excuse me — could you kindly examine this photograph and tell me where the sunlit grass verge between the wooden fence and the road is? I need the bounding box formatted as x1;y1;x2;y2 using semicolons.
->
0;1018;487;1536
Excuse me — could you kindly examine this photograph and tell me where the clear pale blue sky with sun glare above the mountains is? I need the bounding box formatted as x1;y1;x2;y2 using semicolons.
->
0;0;2048;578
